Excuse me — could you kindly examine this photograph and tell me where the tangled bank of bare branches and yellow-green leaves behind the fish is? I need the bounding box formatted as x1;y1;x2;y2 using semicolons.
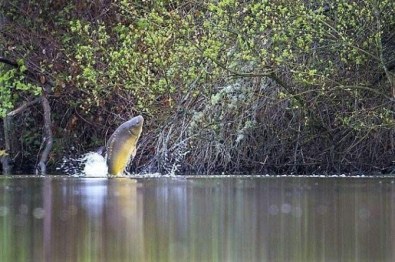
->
0;0;395;173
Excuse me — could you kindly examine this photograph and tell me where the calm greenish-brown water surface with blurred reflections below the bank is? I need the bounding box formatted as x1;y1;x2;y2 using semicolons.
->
0;176;395;262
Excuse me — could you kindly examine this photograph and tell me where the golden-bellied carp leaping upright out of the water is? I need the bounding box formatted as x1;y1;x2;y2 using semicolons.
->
106;116;144;176
